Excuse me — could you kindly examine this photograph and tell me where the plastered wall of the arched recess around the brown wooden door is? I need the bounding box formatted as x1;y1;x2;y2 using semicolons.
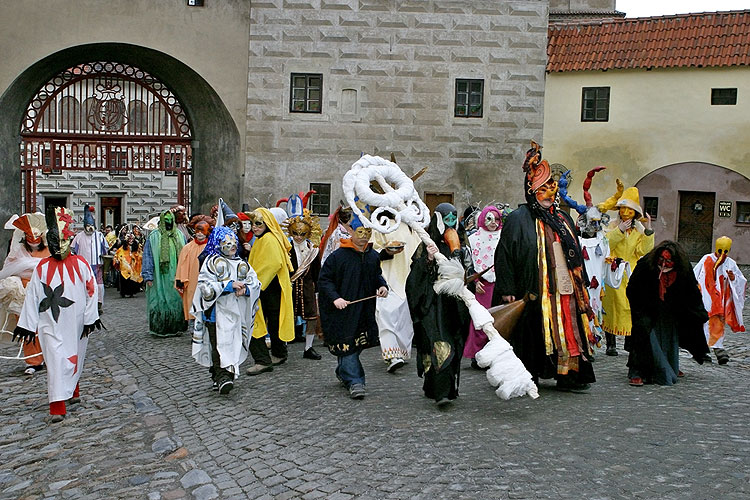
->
635;162;750;264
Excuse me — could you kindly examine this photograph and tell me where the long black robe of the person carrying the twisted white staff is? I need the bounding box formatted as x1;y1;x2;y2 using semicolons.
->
406;238;469;401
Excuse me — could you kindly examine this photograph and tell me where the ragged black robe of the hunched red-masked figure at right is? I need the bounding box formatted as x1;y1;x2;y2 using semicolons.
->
626;250;709;385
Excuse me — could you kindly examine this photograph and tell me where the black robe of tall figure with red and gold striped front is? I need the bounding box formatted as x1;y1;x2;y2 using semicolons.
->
492;204;596;384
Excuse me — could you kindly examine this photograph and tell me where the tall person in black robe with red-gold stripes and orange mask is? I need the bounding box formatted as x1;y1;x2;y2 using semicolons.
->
493;141;596;391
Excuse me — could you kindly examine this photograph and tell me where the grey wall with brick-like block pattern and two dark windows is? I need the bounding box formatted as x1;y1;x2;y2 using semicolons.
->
244;0;548;213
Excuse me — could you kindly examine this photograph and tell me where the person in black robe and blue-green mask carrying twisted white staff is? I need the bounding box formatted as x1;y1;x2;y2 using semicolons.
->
406;203;470;406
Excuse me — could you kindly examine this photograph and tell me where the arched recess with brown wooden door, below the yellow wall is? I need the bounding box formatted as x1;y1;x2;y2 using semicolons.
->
636;162;750;264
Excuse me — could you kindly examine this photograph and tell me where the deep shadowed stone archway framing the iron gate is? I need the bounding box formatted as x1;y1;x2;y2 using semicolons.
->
0;43;244;257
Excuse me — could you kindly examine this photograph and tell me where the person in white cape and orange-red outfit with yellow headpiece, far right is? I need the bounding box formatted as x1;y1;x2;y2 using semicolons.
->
693;236;747;365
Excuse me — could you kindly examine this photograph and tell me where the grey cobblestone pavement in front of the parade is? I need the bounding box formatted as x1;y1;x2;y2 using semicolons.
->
0;290;750;499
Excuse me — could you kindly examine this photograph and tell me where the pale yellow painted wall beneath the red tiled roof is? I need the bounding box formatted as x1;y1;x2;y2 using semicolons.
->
542;67;750;203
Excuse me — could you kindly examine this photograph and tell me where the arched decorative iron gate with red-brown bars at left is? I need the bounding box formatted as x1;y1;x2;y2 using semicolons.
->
21;62;192;213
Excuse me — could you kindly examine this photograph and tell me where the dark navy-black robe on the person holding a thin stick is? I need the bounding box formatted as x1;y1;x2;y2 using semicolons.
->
318;240;388;356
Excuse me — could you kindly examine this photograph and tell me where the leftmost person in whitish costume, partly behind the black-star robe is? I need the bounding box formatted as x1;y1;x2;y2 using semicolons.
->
0;213;50;375
